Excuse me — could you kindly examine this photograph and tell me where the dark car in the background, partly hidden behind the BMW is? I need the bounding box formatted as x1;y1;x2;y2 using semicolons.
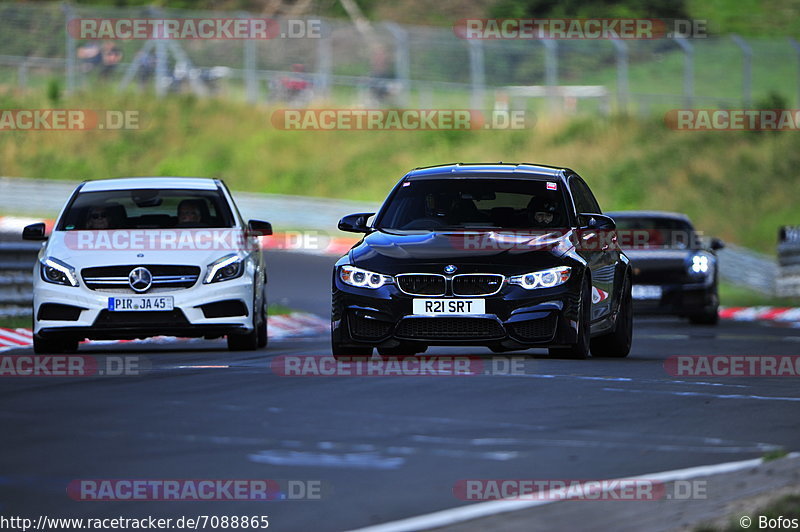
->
607;211;724;325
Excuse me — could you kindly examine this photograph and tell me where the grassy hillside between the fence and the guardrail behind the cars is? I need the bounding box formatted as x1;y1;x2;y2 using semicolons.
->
0;88;800;252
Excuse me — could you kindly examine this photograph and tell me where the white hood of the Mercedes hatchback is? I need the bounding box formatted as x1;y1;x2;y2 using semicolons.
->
41;230;248;271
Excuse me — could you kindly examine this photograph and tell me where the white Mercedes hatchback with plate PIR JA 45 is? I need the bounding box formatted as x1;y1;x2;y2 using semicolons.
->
23;177;272;353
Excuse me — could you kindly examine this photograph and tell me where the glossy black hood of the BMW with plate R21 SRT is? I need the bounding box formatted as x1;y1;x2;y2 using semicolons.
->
350;231;573;273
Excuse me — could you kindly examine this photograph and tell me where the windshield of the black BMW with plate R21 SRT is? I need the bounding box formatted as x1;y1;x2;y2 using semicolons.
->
376;178;568;230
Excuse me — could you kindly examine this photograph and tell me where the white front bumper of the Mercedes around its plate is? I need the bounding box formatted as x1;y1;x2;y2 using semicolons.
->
33;274;254;339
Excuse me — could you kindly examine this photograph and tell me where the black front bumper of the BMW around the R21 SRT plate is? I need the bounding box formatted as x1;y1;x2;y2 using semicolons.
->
331;279;580;349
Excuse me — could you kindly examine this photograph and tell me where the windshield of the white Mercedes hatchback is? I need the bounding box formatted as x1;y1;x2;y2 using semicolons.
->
58;189;234;231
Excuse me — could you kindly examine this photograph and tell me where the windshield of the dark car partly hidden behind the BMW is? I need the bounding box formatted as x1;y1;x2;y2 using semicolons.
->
610;214;698;249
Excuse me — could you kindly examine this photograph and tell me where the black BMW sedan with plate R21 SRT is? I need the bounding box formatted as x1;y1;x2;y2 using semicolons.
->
331;163;633;358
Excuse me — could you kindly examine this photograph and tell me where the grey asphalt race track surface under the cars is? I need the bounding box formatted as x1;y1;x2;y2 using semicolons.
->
0;253;800;531
